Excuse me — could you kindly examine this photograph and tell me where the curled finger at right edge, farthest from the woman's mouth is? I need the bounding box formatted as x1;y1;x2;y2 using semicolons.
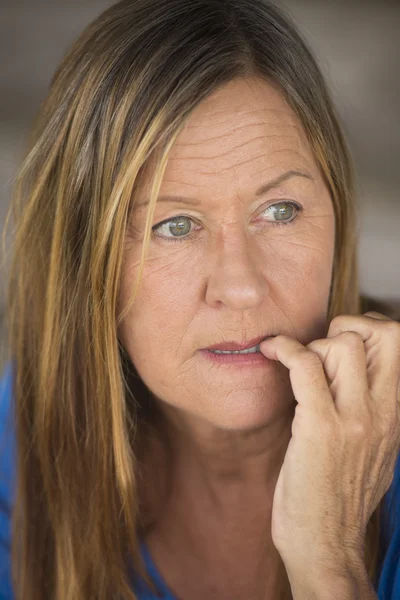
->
327;312;400;401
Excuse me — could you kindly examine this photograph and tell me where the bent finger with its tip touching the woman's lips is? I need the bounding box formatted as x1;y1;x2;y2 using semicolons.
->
260;335;334;413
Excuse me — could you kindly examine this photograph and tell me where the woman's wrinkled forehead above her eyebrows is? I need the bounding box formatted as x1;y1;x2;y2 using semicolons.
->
141;78;321;197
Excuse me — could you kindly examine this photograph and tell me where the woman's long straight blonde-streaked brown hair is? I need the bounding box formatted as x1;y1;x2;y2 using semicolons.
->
3;0;379;600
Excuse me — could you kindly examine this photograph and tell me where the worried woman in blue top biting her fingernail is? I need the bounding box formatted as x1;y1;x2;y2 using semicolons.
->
2;0;400;600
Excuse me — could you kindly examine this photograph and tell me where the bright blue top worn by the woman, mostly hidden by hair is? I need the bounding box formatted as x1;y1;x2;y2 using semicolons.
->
0;363;400;600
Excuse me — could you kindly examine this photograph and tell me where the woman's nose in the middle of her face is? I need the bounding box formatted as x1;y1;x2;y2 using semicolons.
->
206;227;269;310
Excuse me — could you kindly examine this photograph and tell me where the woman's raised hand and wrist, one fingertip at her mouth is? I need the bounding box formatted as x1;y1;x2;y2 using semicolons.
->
260;312;400;574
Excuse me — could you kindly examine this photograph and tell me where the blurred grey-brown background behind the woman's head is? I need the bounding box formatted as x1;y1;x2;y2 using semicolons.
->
0;0;400;368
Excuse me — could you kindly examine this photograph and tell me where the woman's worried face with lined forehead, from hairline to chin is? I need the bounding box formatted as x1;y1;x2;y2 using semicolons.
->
119;78;335;431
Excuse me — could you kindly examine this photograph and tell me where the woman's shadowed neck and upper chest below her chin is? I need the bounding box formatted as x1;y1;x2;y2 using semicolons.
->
139;398;294;598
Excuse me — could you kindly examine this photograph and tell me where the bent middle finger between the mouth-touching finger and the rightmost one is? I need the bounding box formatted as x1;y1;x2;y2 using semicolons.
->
307;331;369;417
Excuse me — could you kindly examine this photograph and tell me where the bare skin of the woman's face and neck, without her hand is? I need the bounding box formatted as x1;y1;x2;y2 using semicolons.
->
119;78;335;600
